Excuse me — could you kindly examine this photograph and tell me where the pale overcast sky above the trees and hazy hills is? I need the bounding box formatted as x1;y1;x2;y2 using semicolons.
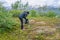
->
0;0;60;6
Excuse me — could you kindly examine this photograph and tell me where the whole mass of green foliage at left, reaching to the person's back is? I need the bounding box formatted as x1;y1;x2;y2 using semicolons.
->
0;4;22;33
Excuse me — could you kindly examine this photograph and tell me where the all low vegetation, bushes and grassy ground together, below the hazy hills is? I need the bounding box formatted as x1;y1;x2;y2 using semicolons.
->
0;0;60;40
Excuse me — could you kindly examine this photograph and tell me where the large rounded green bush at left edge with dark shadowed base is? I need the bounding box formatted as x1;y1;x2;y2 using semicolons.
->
0;12;16;33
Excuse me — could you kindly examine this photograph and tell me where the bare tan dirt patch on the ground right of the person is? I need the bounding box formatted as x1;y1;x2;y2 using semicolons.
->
23;21;59;40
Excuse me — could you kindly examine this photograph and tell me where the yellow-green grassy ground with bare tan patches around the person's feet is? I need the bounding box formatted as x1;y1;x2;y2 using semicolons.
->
0;17;60;40
